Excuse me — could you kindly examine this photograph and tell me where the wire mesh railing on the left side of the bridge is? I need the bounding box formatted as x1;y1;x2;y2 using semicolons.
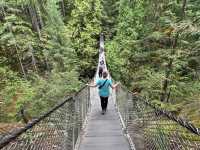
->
0;87;90;150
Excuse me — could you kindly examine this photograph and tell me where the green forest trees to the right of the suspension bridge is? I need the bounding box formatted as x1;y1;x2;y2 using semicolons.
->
106;0;200;124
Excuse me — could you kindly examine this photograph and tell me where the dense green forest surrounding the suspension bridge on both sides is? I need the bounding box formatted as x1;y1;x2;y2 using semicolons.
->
0;0;200;126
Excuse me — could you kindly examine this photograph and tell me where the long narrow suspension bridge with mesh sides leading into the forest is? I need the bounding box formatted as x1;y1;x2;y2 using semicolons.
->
0;35;200;150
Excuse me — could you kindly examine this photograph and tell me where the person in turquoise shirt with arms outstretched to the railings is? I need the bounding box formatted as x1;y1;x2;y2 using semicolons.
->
87;71;119;115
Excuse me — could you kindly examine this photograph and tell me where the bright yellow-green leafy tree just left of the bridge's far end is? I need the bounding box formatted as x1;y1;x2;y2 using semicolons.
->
68;0;102;78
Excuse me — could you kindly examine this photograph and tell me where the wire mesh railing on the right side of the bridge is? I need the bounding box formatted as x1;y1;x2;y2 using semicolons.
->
116;87;200;150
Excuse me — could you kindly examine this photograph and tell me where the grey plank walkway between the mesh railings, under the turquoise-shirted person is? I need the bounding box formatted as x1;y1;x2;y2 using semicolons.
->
79;89;130;150
